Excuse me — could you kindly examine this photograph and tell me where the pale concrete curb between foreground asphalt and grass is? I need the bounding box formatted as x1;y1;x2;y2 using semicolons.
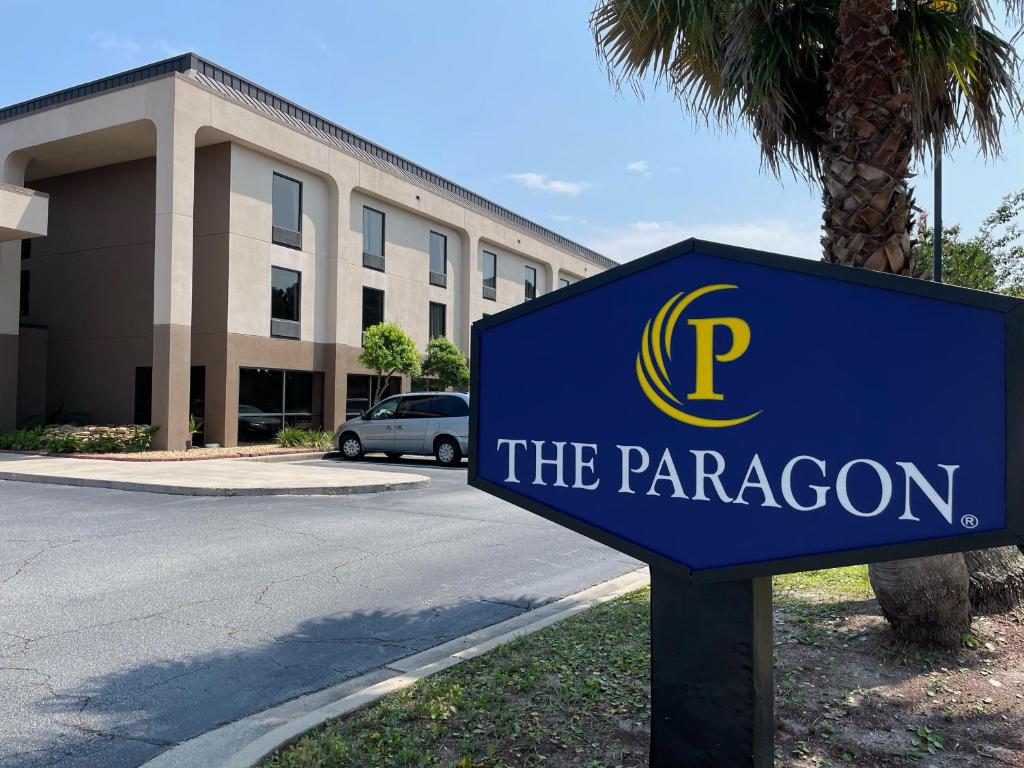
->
141;567;650;768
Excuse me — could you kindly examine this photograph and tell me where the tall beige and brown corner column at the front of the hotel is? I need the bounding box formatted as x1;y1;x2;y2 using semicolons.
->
153;113;196;450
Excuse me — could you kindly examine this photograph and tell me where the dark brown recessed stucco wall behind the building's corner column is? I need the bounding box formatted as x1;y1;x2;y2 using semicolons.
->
26;158;156;424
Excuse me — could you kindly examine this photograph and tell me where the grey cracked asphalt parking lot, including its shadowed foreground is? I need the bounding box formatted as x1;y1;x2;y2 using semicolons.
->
0;458;637;768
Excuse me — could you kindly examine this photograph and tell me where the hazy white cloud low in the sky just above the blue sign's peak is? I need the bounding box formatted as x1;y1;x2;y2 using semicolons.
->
588;218;821;261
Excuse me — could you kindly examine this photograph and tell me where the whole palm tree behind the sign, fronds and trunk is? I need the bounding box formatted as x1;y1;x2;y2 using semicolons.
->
591;0;1020;645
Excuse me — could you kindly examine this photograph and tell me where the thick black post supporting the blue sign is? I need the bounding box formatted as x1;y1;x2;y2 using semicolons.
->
650;566;775;768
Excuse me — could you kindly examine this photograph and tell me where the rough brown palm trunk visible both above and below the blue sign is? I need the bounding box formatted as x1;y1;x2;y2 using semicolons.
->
821;0;971;647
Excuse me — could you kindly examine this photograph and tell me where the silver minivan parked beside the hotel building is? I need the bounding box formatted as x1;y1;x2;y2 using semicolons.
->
334;392;469;467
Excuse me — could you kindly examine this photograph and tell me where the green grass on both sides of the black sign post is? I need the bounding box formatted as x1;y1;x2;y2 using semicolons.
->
264;566;871;768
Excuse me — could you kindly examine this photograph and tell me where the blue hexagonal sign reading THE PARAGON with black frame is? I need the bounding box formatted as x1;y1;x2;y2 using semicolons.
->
470;241;1024;580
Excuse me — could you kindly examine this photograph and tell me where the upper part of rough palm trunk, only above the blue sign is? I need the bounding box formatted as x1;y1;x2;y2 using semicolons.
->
821;0;912;274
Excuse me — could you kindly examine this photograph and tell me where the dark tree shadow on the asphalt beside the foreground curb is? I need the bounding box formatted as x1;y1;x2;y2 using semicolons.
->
19;597;540;768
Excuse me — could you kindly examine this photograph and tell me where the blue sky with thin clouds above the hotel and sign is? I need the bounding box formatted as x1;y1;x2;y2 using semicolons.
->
0;0;1024;261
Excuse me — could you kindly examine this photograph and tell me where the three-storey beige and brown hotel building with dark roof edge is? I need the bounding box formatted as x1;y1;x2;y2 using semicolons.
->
0;53;614;449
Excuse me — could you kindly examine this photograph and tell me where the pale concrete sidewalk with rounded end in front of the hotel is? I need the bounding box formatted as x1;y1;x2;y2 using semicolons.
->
0;454;430;496
